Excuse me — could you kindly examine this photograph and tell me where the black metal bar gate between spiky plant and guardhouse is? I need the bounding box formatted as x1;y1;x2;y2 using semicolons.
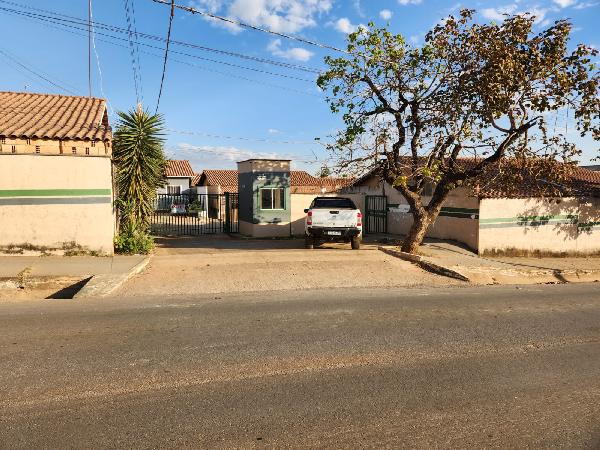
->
151;193;239;236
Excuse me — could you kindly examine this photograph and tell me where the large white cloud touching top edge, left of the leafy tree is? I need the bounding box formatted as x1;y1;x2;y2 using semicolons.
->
192;0;333;33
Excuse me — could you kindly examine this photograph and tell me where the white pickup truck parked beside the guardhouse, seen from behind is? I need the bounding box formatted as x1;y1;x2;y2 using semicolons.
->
304;197;362;250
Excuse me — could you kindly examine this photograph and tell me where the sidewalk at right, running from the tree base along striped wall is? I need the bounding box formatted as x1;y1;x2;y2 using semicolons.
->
420;240;600;284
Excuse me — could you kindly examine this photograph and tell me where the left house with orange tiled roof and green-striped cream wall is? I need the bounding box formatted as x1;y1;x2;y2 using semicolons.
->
0;92;115;254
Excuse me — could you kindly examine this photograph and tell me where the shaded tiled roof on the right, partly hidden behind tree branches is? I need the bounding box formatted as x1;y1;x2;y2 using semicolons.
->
348;158;600;198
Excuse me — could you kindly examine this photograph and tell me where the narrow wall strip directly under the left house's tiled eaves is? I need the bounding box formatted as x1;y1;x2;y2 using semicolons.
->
0;137;112;156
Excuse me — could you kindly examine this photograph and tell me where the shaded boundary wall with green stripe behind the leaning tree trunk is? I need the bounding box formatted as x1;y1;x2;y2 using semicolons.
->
340;177;479;250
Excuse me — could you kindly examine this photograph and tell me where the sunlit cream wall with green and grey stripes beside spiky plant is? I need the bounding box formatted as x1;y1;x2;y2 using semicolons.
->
0;154;115;254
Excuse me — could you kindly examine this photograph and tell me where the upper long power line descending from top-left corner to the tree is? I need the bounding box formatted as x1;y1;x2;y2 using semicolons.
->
0;0;321;74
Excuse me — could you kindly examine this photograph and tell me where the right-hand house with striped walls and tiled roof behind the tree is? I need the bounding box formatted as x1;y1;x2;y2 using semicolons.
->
342;161;600;254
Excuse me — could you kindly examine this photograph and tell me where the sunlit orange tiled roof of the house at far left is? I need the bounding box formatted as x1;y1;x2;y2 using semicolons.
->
0;91;112;141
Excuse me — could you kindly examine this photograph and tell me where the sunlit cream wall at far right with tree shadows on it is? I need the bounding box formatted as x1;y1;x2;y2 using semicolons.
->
479;198;600;254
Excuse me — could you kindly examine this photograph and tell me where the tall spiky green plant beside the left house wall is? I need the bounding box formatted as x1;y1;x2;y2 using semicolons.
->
113;108;166;225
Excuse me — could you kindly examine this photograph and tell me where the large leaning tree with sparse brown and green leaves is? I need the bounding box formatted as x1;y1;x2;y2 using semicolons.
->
318;10;600;253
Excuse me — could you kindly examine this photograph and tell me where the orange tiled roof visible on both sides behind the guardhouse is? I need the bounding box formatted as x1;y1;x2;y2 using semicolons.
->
196;169;352;194
